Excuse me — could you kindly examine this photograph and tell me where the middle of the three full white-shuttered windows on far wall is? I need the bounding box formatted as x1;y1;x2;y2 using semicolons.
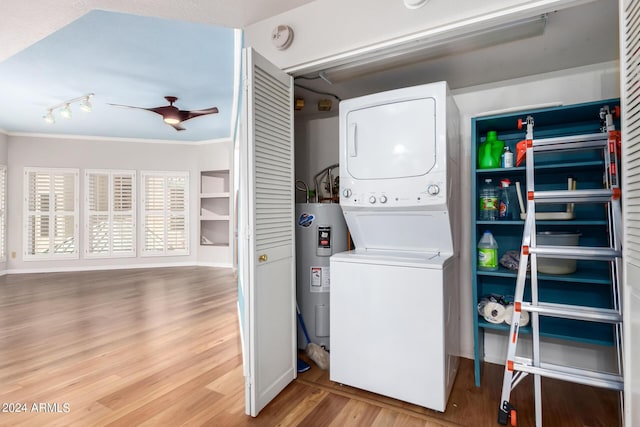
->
84;170;136;258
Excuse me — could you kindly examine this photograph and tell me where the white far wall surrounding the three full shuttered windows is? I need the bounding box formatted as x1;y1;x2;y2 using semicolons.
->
6;135;231;273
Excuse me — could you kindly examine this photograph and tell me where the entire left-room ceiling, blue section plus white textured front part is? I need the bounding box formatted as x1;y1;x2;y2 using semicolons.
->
0;0;311;142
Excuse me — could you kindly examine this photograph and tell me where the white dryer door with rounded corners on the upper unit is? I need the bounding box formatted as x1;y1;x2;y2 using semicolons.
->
345;98;437;179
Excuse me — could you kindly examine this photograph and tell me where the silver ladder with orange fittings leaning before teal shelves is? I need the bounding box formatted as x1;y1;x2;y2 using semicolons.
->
498;107;623;427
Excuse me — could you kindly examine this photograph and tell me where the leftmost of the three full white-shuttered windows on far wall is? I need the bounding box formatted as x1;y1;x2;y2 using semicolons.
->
24;168;79;260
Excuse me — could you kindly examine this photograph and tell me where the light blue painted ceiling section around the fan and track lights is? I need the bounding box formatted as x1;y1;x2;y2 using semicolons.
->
0;10;238;141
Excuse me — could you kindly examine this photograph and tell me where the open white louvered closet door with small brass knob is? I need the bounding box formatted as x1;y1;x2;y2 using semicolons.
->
240;49;296;416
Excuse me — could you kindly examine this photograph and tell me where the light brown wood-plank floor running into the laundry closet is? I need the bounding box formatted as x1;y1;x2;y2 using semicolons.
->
0;267;621;427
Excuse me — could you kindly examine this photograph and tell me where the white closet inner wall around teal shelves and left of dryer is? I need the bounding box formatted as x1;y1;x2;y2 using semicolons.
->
296;63;620;367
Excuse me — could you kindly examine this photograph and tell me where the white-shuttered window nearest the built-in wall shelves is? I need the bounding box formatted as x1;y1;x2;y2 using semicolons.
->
142;172;189;255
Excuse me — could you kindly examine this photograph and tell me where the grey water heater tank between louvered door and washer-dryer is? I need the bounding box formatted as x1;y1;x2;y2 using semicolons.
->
296;203;348;350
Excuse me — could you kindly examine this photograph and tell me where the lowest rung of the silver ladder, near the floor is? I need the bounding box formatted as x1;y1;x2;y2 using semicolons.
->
513;357;624;391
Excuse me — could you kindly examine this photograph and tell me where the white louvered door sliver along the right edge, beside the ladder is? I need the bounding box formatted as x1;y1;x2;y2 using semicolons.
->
620;0;640;426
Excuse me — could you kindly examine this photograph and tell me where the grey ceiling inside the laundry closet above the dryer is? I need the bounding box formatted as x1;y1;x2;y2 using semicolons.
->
296;0;619;118
